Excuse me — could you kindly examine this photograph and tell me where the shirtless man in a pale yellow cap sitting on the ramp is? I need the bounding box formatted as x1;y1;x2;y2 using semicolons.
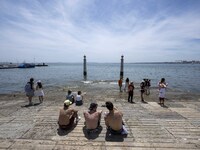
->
58;100;78;129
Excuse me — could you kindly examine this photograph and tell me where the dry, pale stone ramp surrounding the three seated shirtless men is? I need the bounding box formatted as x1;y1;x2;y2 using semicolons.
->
0;100;200;150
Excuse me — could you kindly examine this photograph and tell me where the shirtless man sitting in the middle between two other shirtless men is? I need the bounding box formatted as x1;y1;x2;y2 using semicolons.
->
83;103;102;132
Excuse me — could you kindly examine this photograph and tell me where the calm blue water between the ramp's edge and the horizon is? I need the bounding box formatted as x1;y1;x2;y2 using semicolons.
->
0;63;200;94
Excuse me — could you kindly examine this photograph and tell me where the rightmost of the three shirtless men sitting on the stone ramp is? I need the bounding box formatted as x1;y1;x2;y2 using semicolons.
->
104;102;128;134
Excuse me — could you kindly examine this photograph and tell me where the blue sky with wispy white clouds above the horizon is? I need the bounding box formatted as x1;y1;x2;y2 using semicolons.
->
0;0;200;63
